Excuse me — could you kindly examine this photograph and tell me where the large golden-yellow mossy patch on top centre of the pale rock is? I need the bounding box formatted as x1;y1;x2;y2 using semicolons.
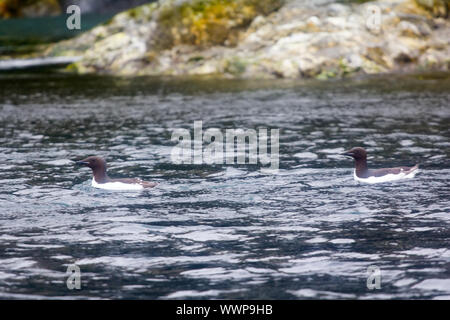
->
153;0;283;49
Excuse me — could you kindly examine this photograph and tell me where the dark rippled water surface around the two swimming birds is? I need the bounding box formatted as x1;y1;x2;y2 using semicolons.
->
0;74;450;299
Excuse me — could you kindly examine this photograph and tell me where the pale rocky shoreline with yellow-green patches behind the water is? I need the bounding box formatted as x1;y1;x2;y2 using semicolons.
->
45;0;450;79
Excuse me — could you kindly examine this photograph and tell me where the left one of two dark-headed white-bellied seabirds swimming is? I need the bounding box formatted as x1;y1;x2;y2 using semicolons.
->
76;156;156;190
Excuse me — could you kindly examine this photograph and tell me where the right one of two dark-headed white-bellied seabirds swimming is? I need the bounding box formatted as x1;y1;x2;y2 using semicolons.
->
341;147;419;183
